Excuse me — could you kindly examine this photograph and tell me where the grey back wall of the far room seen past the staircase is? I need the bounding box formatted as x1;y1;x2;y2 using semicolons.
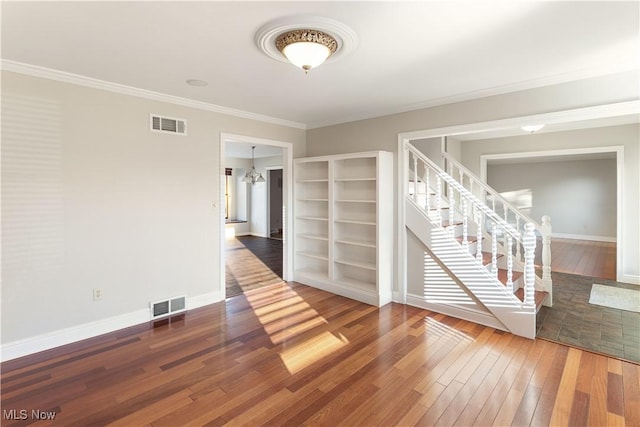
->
487;159;617;242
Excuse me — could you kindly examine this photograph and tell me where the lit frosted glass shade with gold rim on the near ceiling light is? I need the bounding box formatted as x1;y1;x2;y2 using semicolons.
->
276;30;338;72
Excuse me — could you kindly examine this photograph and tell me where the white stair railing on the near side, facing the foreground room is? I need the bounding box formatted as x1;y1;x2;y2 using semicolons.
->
405;144;536;307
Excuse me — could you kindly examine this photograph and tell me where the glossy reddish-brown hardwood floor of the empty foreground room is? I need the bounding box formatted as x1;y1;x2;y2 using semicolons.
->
1;283;640;426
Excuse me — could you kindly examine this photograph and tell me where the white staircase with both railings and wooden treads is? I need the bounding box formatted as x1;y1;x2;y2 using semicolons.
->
405;143;552;338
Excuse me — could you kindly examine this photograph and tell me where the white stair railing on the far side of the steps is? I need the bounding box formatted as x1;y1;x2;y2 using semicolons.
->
442;153;553;304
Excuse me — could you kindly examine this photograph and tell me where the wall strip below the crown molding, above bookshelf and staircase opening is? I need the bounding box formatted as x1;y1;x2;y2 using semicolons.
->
307;72;640;290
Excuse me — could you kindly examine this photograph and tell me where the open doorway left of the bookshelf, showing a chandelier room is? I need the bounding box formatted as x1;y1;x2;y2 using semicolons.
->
220;134;293;298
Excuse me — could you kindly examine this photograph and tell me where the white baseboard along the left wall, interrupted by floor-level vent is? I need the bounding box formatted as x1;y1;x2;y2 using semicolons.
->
0;292;224;362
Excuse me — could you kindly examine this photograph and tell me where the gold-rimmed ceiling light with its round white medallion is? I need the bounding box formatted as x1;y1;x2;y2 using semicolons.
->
255;16;358;73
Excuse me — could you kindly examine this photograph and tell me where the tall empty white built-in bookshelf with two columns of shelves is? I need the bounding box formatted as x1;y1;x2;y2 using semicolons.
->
294;151;393;306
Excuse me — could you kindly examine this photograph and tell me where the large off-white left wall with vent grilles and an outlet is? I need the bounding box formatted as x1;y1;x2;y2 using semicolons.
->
1;71;306;359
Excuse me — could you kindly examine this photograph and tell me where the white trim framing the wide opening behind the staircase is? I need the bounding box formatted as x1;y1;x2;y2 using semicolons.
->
480;145;624;282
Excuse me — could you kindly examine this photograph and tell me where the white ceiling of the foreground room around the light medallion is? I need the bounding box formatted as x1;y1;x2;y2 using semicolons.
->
2;1;640;128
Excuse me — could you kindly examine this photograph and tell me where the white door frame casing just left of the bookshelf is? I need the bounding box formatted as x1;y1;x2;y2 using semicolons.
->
214;132;293;299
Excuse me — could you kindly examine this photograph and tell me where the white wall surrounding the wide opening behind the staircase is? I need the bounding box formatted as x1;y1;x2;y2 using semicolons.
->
462;125;640;283
